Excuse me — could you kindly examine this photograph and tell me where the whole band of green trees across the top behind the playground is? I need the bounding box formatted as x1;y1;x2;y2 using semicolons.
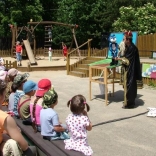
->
0;0;156;48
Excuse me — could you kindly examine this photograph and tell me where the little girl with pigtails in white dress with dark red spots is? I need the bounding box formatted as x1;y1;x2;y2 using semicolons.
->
64;95;93;156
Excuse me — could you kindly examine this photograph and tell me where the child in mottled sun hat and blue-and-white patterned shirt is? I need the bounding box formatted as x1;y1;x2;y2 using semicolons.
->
13;73;29;118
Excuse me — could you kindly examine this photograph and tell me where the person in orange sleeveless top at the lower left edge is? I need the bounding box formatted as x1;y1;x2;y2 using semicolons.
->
0;80;37;156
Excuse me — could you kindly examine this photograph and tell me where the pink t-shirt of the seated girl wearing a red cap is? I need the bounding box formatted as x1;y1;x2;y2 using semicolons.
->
30;97;43;125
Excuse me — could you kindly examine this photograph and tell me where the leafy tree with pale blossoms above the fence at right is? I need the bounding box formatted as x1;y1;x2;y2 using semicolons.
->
113;3;156;34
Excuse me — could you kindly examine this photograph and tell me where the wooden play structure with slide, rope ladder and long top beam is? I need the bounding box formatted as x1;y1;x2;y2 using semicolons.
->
10;21;81;65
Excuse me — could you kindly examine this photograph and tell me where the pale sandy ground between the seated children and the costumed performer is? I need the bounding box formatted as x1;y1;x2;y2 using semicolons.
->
14;71;156;156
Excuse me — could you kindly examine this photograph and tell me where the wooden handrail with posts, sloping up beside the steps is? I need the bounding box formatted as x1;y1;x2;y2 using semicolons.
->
67;39;92;75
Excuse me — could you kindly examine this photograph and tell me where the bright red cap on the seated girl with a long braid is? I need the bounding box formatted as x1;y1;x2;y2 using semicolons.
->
36;79;51;97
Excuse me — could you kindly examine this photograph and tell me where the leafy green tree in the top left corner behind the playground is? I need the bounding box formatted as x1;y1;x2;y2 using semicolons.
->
0;0;42;36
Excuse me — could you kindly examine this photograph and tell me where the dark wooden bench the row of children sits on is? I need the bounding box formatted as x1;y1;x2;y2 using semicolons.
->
14;118;84;156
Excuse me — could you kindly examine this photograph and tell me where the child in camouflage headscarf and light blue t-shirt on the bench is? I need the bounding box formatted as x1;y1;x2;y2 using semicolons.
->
40;89;69;141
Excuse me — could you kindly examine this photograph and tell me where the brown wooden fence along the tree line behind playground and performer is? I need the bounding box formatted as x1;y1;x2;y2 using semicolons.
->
0;33;156;57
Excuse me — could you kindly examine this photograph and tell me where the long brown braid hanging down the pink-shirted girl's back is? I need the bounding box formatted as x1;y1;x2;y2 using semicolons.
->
32;97;41;133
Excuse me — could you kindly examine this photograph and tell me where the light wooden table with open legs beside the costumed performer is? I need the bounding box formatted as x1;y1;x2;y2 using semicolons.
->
89;64;119;105
